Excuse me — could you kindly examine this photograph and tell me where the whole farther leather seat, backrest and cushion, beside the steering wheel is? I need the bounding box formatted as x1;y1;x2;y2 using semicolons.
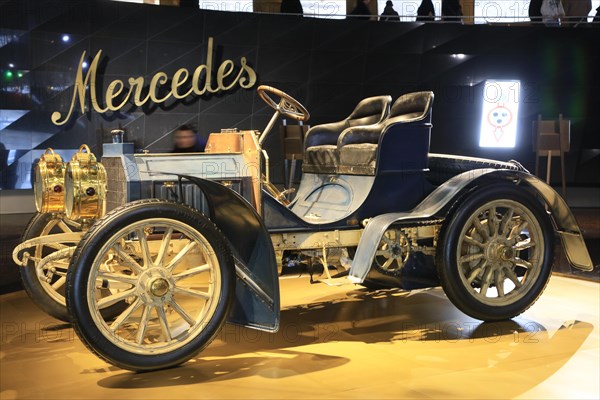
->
302;96;392;174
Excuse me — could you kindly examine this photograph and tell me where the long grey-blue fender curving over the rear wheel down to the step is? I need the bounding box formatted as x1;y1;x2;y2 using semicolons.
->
349;168;593;283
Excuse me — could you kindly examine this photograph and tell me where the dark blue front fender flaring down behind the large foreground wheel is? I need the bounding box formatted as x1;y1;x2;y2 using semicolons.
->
178;175;279;332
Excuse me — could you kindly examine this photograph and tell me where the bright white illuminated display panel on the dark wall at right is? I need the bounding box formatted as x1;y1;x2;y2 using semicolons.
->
479;80;521;147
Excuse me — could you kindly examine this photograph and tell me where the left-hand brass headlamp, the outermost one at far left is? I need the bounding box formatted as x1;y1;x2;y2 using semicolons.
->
33;148;65;213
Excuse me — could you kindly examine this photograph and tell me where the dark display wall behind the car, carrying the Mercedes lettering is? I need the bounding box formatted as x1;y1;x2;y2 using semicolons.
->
0;0;600;189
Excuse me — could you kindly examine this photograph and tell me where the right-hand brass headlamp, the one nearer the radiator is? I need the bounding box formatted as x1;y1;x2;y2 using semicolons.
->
65;144;106;220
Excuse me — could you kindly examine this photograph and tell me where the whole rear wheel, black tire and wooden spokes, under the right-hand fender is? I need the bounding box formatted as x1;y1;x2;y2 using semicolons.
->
437;185;554;321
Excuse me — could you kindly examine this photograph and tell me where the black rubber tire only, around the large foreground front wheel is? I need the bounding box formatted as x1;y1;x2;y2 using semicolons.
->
66;199;235;371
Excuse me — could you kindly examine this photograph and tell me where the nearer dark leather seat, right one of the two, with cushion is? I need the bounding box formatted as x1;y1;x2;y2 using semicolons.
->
337;92;433;175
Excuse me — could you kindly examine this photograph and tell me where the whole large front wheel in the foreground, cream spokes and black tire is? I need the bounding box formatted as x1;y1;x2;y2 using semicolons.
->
67;200;235;371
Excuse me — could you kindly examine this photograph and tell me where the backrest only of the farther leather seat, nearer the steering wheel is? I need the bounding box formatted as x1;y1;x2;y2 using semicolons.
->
304;96;392;149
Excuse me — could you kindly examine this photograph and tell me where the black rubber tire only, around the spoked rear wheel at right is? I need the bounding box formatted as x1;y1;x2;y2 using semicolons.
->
436;184;554;321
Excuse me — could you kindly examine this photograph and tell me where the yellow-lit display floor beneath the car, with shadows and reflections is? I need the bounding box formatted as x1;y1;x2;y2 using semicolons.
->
0;276;600;399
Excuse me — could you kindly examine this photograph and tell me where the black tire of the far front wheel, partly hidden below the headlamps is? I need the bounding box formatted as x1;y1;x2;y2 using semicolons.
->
19;213;71;322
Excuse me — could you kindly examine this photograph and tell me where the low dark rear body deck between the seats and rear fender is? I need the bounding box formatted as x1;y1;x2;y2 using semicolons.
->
426;153;523;185
